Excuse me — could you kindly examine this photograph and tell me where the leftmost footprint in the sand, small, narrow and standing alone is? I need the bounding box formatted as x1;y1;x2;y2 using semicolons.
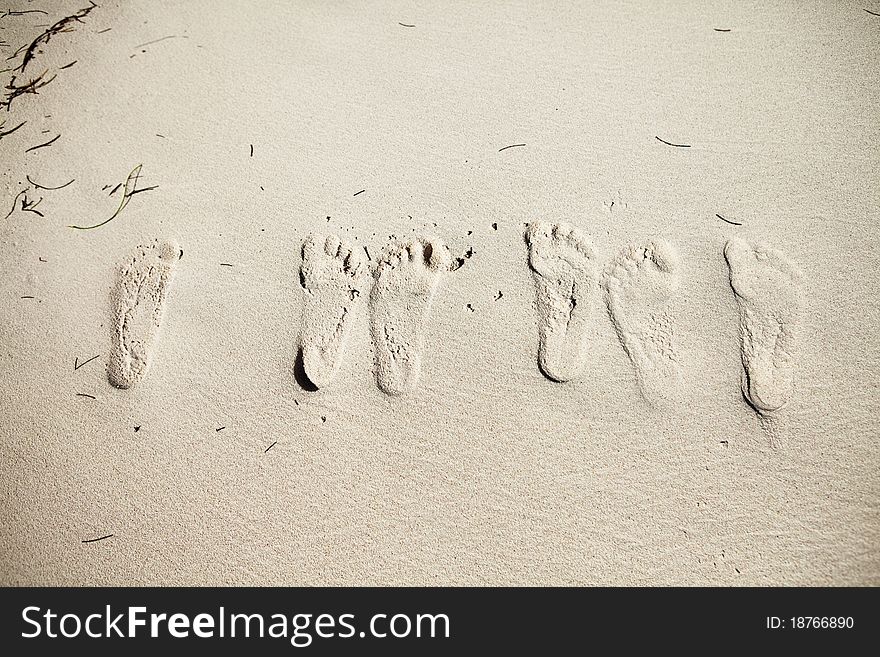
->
107;240;183;389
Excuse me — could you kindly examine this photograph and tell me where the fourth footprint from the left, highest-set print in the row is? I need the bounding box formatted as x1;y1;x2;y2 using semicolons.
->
526;221;597;381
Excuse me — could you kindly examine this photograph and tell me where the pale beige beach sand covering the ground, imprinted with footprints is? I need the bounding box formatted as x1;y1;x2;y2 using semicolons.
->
0;0;880;586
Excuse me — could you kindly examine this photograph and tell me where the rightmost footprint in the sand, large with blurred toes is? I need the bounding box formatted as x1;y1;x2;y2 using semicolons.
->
724;239;802;414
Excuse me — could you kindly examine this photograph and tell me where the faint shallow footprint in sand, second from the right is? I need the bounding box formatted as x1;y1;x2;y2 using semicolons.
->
602;240;681;406
